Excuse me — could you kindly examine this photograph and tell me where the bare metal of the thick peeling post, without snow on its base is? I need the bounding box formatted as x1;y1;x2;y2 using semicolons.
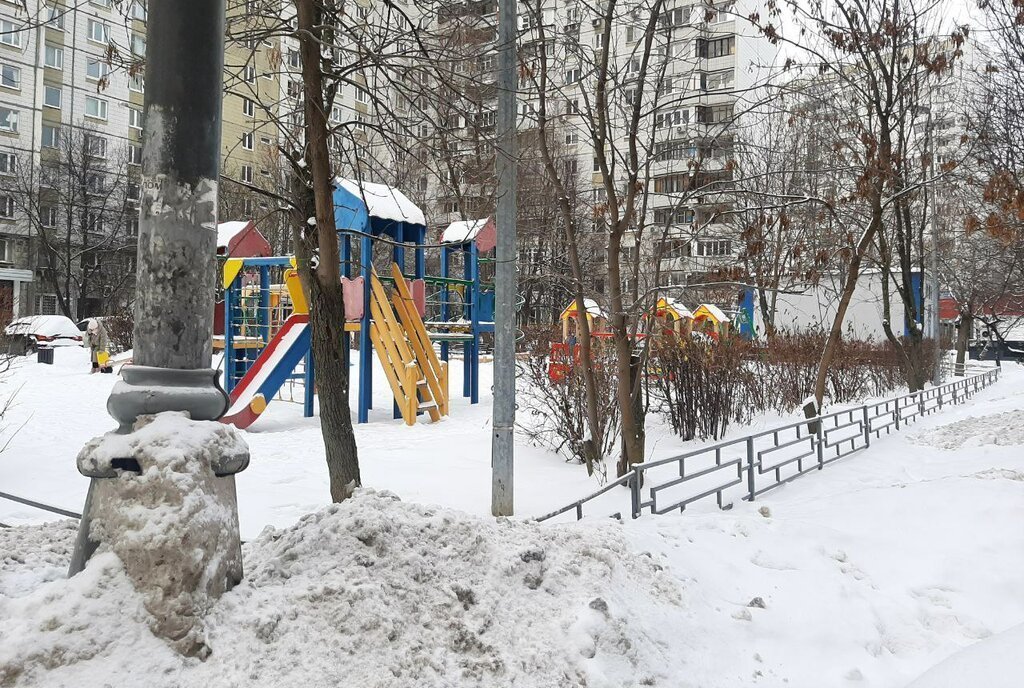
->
70;0;249;593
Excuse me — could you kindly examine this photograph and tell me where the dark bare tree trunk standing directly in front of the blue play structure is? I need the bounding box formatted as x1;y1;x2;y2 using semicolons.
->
294;0;360;502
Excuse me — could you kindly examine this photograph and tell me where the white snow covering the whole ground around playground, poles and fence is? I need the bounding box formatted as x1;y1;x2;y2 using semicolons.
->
0;352;1024;688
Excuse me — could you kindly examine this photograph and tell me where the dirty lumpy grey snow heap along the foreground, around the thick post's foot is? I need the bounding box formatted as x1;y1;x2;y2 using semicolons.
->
0;490;682;688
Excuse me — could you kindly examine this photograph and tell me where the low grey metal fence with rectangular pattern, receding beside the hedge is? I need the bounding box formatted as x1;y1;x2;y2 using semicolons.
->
536;368;999;521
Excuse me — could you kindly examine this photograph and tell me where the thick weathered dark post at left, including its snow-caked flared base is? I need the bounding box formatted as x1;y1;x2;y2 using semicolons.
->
69;0;249;638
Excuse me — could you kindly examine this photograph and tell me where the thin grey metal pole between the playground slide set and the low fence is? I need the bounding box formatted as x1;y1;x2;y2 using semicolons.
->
490;0;517;516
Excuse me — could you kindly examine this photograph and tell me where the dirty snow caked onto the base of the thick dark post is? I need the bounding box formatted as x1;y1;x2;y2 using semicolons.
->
78;412;248;655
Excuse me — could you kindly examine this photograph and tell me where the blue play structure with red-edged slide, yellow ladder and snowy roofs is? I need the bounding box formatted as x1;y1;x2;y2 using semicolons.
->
222;179;494;428
